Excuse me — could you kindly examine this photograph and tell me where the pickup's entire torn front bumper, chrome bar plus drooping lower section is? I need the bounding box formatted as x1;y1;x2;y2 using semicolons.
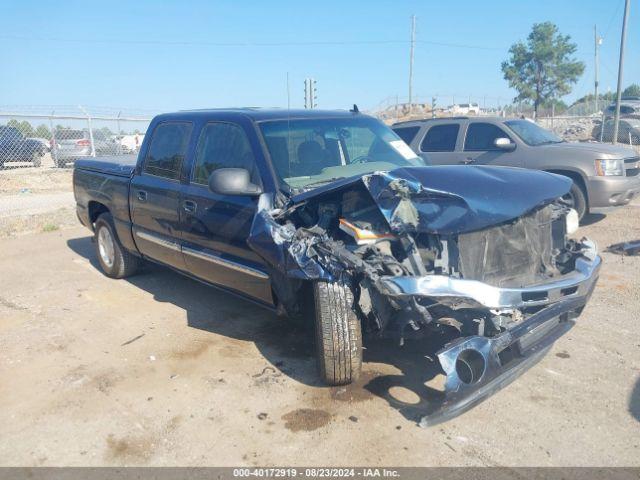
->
381;240;601;427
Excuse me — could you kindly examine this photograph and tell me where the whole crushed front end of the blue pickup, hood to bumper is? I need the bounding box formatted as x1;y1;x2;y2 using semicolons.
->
249;167;600;425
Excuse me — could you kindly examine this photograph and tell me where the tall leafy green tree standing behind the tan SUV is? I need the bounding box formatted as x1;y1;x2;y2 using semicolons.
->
502;22;584;116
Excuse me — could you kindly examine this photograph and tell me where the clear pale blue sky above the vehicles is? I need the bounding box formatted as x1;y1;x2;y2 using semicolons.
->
0;0;640;110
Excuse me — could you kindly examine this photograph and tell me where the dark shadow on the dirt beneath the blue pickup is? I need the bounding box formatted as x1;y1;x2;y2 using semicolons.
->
67;237;446;421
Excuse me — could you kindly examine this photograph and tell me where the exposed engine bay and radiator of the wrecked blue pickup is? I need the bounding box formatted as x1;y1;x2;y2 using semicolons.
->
252;167;583;342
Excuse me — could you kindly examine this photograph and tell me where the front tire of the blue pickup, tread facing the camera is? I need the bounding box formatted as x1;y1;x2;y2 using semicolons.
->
313;282;362;385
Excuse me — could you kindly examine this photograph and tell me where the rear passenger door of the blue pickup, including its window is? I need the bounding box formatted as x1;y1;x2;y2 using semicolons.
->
129;122;193;270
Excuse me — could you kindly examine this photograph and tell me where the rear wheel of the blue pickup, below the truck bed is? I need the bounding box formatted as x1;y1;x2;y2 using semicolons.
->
94;213;141;278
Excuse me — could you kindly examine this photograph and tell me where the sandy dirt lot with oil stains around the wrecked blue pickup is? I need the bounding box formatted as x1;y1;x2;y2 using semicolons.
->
0;168;640;466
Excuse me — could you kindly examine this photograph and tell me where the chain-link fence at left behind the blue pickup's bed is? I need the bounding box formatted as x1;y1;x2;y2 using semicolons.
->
0;107;152;170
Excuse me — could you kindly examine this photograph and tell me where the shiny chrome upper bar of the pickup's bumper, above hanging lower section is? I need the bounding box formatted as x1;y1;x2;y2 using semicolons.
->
377;240;601;309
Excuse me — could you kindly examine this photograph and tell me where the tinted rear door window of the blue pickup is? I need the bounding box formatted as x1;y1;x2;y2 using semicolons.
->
143;122;193;180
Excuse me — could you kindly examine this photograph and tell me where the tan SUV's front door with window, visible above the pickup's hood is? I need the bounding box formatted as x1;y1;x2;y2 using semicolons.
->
457;121;523;167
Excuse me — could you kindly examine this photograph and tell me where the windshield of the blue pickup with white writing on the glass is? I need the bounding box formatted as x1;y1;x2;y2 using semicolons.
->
260;117;424;190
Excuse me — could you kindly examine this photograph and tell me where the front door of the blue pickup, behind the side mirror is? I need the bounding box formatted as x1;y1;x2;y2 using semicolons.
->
180;122;273;305
